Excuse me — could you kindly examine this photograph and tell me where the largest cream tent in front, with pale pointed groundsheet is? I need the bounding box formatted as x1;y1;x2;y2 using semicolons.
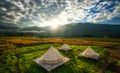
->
34;47;69;71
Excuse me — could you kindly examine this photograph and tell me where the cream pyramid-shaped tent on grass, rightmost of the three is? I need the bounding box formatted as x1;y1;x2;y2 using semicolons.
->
80;47;99;59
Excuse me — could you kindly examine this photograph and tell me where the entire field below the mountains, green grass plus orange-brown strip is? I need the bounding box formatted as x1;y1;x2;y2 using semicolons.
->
0;37;120;73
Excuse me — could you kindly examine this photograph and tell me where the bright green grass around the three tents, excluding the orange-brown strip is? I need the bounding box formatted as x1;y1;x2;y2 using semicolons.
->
0;44;109;73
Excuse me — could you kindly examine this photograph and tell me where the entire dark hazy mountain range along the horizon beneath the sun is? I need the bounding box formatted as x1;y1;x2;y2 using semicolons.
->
0;23;120;37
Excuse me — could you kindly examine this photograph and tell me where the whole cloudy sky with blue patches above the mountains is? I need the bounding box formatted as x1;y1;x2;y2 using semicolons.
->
0;0;120;27
